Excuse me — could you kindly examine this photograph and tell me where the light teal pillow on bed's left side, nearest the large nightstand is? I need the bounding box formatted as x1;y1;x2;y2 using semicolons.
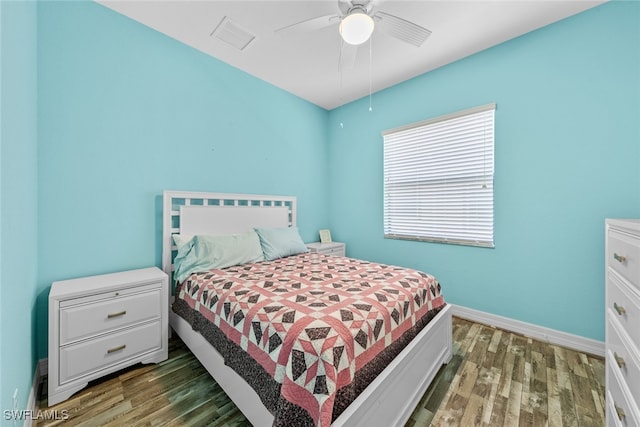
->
173;231;264;282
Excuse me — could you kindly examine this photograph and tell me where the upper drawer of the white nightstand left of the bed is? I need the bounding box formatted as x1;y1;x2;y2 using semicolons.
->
60;288;162;345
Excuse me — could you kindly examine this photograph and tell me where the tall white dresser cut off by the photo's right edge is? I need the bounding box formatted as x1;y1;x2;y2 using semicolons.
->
605;219;640;427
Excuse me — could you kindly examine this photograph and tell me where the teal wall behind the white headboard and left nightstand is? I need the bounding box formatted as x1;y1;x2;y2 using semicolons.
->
38;2;328;357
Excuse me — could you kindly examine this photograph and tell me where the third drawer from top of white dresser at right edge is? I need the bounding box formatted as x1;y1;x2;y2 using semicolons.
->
607;317;640;402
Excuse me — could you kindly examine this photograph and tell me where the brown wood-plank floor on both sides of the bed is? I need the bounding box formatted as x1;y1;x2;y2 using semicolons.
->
34;317;605;427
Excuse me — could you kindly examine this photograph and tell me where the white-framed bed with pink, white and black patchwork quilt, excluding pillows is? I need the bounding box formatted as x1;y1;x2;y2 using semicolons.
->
162;191;452;426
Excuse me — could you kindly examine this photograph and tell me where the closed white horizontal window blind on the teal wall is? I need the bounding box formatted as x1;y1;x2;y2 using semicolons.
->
382;104;496;247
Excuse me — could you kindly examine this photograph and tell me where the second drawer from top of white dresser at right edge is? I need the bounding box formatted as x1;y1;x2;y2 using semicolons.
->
607;271;640;348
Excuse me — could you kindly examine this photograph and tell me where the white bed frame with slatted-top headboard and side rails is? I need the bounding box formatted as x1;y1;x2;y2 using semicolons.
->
162;191;452;427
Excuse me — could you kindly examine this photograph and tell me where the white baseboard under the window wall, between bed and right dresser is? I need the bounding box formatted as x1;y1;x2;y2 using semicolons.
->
451;304;605;357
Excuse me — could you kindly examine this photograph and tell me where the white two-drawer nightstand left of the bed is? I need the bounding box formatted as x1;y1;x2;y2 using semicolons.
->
48;267;169;406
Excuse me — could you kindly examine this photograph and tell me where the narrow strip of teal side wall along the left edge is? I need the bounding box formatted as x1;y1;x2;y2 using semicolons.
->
0;1;38;425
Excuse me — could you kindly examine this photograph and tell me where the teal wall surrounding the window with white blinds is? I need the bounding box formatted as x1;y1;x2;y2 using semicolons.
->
328;2;640;340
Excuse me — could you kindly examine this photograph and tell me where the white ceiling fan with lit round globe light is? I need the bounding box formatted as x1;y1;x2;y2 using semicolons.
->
276;0;431;68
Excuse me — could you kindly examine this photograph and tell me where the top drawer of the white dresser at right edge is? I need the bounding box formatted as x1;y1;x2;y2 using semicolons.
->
607;230;640;290
